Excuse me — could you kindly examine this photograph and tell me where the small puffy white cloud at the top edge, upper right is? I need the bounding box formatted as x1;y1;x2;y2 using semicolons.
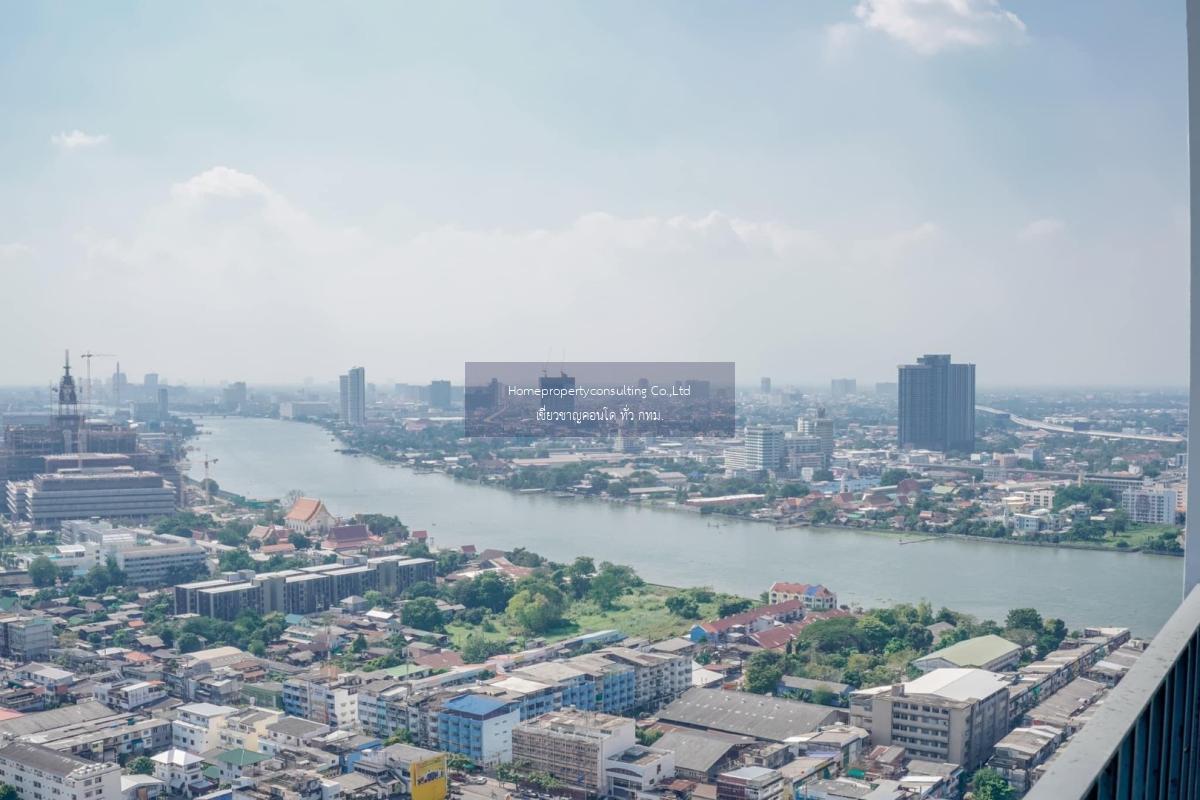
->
828;0;1025;55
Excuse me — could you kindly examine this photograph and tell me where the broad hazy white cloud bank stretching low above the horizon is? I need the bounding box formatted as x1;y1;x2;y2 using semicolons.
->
28;167;1186;383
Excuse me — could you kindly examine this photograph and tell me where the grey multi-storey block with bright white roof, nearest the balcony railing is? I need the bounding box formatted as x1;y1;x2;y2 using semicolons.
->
850;669;1009;771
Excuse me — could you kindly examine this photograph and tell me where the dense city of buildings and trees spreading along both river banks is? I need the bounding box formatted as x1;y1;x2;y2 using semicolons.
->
0;353;1187;800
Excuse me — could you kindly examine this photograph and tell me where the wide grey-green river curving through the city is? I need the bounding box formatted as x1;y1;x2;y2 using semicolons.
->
184;417;1183;636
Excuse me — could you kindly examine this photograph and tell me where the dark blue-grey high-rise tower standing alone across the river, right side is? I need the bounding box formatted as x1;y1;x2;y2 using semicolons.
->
899;354;974;452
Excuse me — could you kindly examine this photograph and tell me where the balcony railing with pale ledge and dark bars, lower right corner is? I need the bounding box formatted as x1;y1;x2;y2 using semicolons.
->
1026;588;1200;800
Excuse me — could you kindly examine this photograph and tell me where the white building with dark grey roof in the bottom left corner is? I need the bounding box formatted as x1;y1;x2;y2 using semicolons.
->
0;741;121;800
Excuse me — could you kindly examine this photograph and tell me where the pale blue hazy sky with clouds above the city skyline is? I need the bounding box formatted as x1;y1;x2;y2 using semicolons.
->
0;0;1188;386
